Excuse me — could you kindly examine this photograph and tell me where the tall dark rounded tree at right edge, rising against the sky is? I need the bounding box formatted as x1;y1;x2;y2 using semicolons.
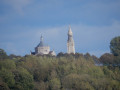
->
110;36;120;56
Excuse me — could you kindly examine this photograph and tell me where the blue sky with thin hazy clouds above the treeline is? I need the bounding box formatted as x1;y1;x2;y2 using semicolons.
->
0;0;120;57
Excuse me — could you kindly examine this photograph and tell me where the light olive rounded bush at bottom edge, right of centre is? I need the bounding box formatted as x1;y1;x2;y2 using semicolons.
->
63;74;94;90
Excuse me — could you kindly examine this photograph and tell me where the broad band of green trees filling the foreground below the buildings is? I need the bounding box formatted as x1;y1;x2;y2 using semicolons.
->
0;36;120;90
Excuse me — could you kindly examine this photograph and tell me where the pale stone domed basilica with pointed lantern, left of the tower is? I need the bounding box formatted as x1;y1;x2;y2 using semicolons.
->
31;36;56;56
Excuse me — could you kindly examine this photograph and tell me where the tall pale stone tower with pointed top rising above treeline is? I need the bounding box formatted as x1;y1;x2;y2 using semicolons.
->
67;26;75;54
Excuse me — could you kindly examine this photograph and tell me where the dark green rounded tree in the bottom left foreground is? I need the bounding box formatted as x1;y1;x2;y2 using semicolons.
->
14;67;33;90
